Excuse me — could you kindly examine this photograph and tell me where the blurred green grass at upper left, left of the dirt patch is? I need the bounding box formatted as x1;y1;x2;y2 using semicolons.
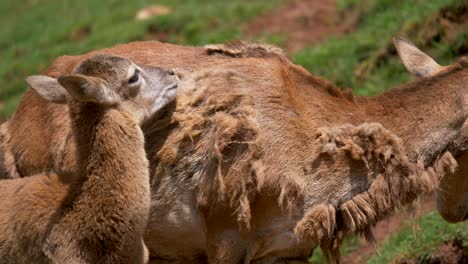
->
0;0;286;118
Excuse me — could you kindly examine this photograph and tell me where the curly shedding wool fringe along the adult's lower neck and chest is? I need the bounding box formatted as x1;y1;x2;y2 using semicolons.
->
295;123;457;262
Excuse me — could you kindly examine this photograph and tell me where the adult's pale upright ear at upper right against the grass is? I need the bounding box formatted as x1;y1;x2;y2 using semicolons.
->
393;37;445;78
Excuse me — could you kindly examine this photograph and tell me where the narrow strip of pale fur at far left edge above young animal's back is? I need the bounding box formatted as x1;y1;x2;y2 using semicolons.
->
0;122;21;179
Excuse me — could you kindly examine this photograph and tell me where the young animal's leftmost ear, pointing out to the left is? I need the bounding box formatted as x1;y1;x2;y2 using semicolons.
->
26;75;67;104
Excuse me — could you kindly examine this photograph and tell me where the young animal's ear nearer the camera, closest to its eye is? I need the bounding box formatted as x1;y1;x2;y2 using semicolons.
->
57;74;120;106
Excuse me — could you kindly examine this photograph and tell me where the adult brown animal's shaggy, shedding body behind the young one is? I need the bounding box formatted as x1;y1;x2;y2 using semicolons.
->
3;40;468;263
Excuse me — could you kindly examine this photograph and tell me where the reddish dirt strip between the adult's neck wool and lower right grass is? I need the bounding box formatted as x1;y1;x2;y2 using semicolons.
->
341;195;435;264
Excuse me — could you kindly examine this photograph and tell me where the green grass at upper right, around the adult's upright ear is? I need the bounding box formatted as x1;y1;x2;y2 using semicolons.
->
294;0;468;95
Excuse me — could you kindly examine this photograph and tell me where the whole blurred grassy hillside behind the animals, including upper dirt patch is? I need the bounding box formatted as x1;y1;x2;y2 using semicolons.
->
0;0;468;263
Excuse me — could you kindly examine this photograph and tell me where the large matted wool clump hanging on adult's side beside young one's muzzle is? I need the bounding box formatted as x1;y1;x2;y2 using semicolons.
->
148;70;263;228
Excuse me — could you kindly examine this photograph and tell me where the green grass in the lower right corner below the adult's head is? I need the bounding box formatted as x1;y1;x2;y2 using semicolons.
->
367;212;468;264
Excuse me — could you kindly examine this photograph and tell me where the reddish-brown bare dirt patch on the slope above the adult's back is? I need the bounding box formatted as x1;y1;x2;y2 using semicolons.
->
245;0;359;53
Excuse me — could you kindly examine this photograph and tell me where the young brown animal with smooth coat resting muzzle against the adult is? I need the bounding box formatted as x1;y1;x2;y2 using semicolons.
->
0;54;178;263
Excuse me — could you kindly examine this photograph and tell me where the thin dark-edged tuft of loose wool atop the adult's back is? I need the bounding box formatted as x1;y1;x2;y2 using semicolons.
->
204;40;286;58
